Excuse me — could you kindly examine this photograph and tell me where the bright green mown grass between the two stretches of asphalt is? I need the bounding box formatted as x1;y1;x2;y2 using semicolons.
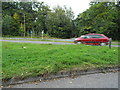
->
2;42;118;79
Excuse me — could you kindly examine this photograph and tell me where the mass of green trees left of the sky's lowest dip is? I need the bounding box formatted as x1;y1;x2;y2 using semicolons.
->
2;2;73;38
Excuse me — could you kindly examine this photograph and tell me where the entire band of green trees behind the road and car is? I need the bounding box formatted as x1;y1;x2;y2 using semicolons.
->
2;1;120;40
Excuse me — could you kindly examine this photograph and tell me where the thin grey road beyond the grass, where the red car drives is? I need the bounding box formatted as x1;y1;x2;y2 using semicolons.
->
0;40;120;47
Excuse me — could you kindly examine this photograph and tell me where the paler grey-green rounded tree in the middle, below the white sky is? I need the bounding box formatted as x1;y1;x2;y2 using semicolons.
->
46;6;74;38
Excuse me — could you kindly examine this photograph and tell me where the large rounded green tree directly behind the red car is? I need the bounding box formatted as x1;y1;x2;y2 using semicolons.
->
76;2;120;40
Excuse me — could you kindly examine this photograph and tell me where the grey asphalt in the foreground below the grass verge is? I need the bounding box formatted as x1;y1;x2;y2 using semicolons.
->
4;72;118;88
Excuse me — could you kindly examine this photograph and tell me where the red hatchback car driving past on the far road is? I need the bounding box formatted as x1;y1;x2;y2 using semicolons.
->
74;34;109;46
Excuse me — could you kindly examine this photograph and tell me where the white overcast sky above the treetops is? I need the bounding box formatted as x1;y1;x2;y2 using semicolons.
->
38;0;90;17
